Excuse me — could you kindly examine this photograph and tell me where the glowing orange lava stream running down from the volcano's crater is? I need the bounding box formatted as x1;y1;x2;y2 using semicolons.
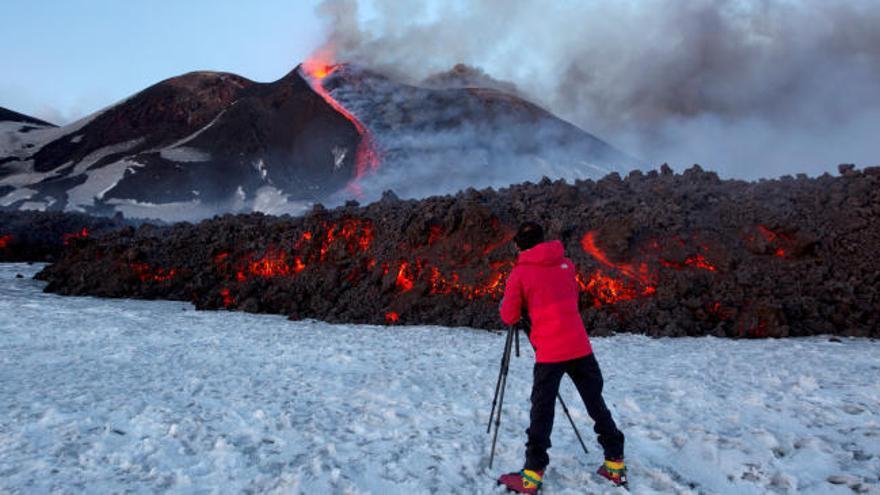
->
302;50;379;197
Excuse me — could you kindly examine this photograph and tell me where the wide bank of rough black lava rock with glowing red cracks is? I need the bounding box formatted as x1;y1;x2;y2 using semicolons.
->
34;167;880;337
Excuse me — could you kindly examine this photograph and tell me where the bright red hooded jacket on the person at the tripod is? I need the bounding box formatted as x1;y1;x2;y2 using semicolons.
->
501;241;593;363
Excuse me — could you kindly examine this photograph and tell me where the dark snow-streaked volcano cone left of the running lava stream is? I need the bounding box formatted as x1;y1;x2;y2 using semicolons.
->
0;70;360;218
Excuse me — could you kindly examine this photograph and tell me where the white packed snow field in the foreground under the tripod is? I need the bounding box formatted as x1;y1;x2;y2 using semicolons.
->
0;264;880;494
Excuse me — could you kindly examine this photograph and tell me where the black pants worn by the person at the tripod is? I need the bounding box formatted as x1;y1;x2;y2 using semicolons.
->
525;354;624;471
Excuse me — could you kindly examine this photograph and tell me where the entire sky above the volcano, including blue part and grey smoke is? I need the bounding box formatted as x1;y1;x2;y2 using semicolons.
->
0;0;880;179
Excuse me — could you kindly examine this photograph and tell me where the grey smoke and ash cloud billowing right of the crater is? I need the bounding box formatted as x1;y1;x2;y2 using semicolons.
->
319;0;880;178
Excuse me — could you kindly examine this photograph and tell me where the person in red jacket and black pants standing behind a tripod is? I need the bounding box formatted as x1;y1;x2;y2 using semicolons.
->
498;222;626;493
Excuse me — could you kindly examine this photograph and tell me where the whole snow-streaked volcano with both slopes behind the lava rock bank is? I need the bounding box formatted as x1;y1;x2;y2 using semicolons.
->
0;65;635;221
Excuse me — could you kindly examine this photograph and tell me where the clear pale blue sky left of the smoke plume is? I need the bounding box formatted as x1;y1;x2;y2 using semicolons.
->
0;0;326;124
